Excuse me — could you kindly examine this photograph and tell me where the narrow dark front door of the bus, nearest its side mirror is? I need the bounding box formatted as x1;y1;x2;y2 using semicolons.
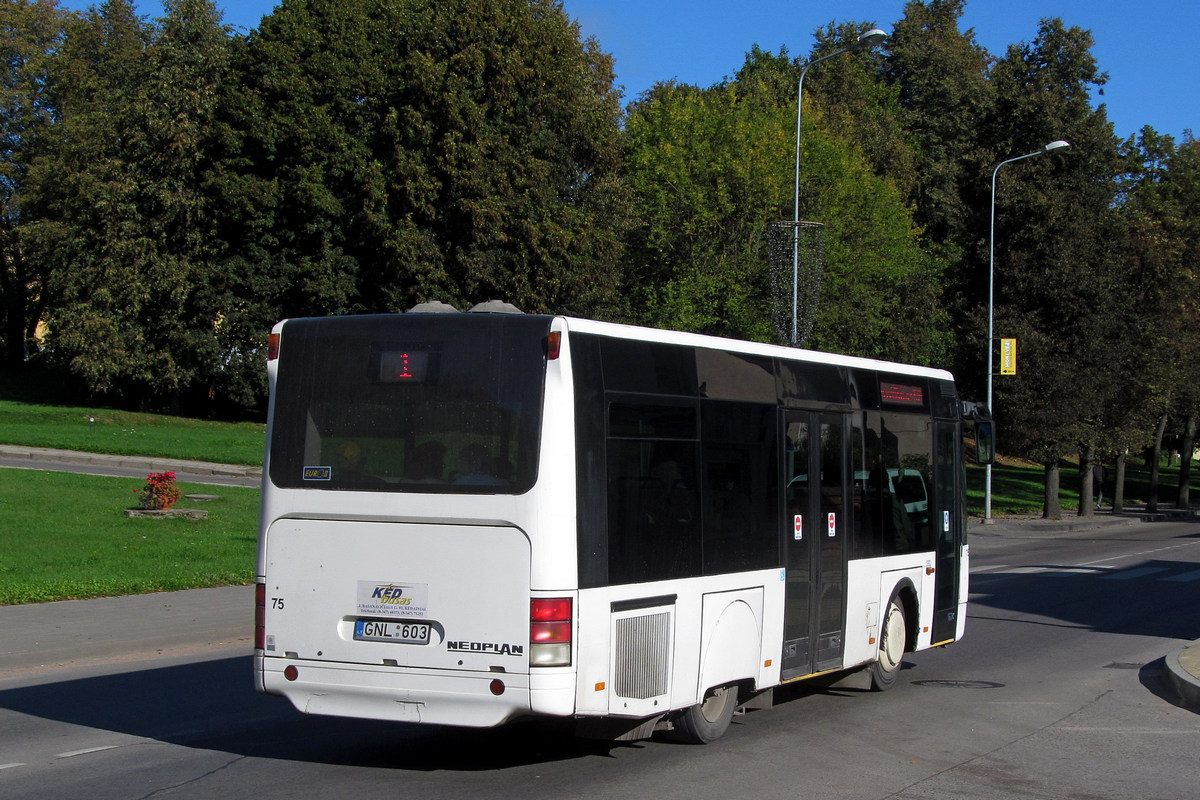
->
930;420;965;644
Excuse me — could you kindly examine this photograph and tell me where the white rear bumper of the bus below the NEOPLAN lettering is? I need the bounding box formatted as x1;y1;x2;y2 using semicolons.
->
254;654;575;728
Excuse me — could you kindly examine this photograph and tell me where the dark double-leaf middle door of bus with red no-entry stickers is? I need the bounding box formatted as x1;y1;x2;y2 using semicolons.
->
782;411;850;680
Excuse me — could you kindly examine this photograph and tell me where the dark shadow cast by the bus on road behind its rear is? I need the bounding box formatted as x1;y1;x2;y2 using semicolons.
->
0;656;640;771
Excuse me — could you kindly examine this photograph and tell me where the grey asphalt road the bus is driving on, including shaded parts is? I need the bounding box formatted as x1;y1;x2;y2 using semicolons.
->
0;522;1200;800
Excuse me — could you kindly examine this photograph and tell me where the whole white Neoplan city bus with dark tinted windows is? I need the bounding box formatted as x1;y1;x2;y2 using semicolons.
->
254;313;971;741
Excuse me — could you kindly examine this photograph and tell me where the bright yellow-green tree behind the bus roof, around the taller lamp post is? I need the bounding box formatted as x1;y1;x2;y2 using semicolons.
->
626;36;947;363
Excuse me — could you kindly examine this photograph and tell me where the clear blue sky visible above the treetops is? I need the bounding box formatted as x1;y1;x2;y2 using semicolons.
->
54;0;1200;139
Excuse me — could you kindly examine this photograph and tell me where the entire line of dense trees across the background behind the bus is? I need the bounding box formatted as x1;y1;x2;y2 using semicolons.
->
0;0;1200;516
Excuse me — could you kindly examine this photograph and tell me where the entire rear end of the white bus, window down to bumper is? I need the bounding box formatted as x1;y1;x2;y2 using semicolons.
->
256;314;575;726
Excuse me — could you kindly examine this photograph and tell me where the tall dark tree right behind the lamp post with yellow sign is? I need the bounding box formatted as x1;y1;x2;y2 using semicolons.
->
991;19;1127;517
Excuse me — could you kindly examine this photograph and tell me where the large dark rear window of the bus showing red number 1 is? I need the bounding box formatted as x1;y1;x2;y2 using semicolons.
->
270;314;551;494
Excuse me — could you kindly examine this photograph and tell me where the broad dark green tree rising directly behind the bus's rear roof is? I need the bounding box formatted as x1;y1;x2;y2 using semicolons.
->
222;0;628;328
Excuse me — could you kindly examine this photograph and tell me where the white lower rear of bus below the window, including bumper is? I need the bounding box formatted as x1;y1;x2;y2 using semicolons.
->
262;518;544;724
